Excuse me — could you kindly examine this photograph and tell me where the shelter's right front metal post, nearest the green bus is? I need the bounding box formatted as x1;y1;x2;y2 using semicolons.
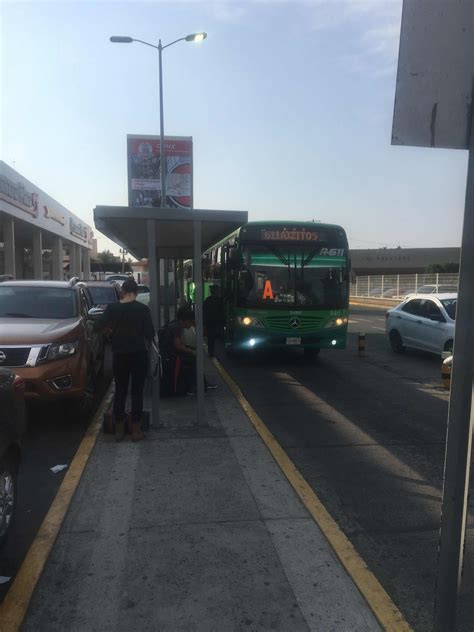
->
193;220;207;426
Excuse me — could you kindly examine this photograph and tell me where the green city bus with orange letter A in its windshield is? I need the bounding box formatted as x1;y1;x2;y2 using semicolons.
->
203;221;349;359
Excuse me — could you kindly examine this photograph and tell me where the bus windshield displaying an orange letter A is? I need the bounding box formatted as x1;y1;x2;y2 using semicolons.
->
238;244;348;310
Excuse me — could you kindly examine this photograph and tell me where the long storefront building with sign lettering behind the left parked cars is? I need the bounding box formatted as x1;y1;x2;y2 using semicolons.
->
0;161;94;280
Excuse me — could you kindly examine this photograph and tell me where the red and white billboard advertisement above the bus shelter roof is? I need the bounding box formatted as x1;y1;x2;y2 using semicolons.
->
127;134;193;209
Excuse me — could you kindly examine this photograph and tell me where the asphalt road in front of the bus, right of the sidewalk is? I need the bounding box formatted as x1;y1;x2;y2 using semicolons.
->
219;307;474;632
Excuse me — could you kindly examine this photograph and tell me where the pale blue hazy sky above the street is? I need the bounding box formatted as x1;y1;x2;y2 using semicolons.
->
0;0;467;252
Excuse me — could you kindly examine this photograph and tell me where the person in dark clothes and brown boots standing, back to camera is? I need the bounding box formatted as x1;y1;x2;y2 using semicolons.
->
94;278;155;441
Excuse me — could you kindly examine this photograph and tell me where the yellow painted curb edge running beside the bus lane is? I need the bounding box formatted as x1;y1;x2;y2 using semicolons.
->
213;358;412;632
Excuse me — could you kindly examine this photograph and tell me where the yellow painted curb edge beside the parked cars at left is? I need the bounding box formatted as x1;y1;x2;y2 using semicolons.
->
0;385;113;632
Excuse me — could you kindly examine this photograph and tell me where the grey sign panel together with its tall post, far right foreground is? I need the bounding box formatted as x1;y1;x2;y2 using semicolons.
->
392;0;474;632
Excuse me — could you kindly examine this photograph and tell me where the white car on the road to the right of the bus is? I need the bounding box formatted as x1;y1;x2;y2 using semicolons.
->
385;293;458;355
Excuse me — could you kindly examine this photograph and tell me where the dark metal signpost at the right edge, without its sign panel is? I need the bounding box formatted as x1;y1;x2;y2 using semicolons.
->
434;89;474;632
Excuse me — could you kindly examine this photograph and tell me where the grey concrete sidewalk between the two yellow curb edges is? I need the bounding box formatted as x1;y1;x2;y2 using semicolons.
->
22;364;381;632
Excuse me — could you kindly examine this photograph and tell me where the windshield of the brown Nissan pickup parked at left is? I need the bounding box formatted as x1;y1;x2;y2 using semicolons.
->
0;286;77;320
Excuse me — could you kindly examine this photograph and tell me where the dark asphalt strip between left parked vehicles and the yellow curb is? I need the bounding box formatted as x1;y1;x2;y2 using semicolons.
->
0;353;112;600
